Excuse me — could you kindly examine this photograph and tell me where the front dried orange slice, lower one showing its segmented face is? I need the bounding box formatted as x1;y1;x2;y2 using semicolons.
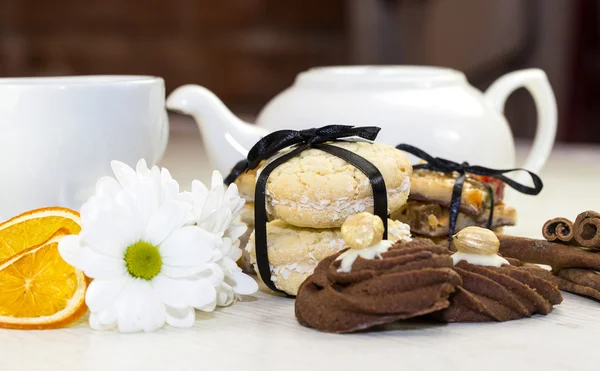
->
0;229;87;329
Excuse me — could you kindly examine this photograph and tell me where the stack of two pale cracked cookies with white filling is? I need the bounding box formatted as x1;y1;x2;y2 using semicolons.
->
247;142;412;295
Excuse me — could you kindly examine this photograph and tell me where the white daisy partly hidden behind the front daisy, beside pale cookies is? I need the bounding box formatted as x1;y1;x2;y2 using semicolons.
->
182;171;258;306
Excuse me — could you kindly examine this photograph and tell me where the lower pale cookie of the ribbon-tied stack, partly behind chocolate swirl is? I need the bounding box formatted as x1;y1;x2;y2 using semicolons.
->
246;219;410;295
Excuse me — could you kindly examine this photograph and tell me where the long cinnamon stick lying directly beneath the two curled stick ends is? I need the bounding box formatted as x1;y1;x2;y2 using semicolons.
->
498;234;600;271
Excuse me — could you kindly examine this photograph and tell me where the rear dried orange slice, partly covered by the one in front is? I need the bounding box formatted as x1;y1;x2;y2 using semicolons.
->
0;207;81;261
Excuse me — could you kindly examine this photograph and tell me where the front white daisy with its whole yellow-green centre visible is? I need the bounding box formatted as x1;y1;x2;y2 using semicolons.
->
58;160;222;332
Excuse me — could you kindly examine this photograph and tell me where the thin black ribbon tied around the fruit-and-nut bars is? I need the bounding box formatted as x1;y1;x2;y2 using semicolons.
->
396;144;544;240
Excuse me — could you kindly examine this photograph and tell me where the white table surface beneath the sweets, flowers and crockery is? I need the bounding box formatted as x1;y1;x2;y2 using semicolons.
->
0;120;600;371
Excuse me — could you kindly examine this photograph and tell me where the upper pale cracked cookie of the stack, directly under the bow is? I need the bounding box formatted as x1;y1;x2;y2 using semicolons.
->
266;142;412;228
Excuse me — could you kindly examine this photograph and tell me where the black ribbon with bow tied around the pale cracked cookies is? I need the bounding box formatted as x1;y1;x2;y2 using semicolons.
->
230;125;387;292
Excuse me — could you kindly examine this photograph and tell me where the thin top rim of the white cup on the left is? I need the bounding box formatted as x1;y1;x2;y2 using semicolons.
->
0;75;163;87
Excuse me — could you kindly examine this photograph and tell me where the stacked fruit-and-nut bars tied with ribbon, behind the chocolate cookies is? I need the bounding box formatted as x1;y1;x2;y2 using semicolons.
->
390;169;517;239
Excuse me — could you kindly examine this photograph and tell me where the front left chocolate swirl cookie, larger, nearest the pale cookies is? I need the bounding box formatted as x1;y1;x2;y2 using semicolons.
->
295;240;461;333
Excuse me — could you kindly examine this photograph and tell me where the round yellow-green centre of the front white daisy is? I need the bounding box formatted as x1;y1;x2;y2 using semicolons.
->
125;241;162;280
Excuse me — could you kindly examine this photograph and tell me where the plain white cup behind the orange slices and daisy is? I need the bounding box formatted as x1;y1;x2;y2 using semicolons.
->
0;76;169;219
